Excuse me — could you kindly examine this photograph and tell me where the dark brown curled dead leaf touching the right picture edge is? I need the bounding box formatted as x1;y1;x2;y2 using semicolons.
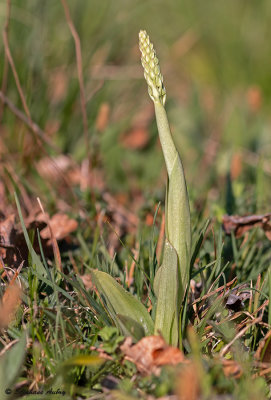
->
222;213;271;240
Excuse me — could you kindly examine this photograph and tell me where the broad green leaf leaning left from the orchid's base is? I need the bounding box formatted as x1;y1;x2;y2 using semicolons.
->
91;271;153;335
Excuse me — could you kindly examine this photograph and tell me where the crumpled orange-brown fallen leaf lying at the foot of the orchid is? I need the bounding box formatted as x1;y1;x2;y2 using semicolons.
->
120;336;185;375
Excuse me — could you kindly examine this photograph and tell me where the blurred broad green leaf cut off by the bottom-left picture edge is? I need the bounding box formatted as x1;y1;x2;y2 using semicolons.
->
0;332;26;399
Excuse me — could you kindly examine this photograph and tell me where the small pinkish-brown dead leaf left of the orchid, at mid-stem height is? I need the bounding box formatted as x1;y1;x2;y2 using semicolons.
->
40;213;78;240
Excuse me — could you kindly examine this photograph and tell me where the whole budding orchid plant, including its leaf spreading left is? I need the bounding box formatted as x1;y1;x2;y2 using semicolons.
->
92;31;191;346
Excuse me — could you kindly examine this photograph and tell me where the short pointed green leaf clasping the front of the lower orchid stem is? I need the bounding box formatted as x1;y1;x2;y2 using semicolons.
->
154;240;179;346
